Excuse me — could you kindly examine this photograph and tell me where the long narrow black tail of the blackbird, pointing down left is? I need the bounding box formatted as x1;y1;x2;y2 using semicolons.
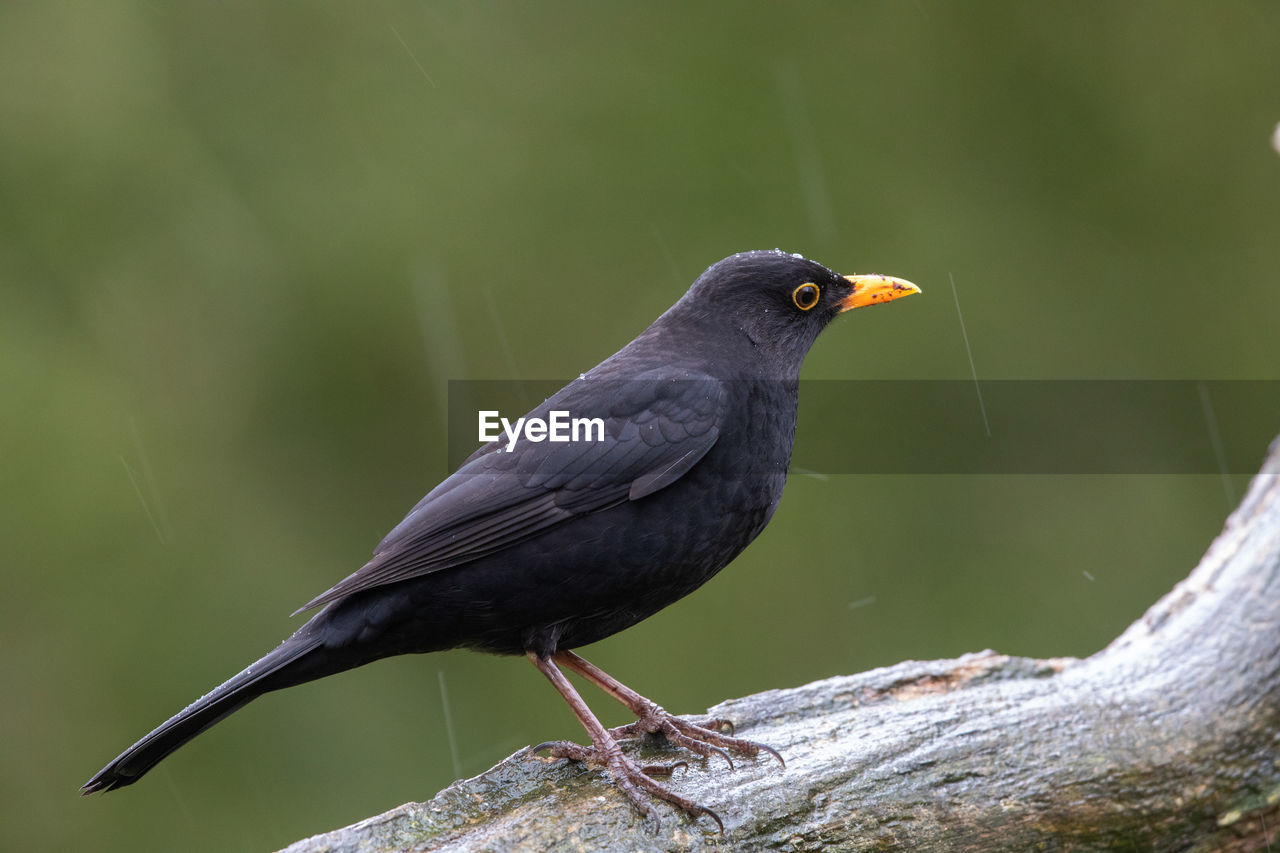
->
81;625;330;794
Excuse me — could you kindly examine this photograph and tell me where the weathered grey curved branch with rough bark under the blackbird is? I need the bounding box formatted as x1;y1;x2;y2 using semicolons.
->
280;439;1280;853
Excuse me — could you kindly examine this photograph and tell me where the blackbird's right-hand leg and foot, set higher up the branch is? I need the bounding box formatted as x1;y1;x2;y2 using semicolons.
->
553;652;786;767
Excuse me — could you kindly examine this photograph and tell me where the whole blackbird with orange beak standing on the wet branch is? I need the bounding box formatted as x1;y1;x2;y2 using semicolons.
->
81;250;919;824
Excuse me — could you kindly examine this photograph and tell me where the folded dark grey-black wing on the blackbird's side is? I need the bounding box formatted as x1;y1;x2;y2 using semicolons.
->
300;374;726;612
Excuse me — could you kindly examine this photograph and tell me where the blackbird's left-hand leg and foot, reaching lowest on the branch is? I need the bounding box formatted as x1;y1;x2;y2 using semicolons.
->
529;652;724;833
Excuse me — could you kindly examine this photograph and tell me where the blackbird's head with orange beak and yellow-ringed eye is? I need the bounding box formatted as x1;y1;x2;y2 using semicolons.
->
681;250;920;370
